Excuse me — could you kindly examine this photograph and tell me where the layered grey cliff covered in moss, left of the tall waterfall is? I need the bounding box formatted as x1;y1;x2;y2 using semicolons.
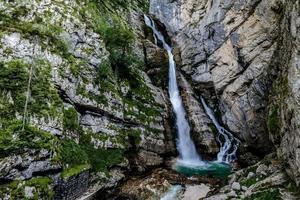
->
0;0;175;199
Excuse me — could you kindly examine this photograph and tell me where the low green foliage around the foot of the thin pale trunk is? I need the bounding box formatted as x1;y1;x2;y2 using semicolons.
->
0;121;58;158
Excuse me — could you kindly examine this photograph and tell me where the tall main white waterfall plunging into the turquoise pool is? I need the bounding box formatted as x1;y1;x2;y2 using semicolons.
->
144;15;203;165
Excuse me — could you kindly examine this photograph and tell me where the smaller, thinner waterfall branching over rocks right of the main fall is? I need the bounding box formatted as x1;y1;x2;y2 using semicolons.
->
201;97;240;163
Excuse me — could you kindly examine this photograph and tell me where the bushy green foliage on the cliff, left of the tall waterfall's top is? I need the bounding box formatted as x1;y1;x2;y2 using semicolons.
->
81;1;138;79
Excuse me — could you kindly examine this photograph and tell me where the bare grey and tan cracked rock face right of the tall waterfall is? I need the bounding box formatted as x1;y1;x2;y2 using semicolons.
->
150;0;284;152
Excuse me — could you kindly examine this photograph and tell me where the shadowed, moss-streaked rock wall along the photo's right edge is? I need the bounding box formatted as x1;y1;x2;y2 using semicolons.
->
268;1;300;186
